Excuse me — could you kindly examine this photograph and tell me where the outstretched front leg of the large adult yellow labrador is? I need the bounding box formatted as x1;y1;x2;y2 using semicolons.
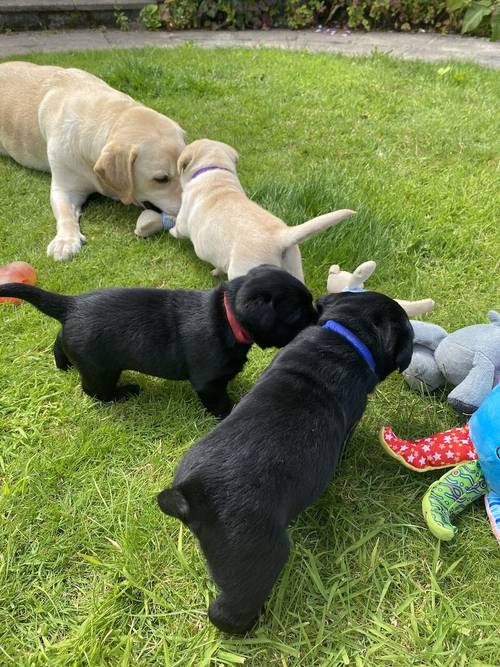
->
47;171;90;260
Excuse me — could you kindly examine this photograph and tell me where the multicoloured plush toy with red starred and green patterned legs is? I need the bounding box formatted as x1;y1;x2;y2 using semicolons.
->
380;385;500;542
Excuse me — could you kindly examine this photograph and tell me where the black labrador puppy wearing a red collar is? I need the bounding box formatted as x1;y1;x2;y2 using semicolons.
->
0;265;317;418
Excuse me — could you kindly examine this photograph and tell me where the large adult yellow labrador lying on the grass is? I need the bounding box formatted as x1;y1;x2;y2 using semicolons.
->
0;62;185;259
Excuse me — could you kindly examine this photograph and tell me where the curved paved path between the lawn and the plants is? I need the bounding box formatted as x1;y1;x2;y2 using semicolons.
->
0;29;500;68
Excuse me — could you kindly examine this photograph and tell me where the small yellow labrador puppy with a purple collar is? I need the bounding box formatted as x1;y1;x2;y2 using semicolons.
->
170;139;354;282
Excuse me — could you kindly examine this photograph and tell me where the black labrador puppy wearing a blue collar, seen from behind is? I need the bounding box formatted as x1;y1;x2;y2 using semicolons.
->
158;292;413;633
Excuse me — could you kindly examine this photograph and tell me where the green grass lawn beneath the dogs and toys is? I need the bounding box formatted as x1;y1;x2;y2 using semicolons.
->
0;47;500;667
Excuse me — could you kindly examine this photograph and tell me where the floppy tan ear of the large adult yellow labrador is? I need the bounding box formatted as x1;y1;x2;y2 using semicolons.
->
94;141;137;204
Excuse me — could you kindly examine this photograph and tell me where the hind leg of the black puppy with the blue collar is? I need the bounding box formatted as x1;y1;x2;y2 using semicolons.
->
208;531;290;634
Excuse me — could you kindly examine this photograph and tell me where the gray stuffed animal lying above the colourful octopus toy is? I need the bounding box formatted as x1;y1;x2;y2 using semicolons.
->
403;310;500;415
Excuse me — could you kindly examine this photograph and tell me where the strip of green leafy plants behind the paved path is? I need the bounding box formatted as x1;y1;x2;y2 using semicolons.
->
154;0;500;39
